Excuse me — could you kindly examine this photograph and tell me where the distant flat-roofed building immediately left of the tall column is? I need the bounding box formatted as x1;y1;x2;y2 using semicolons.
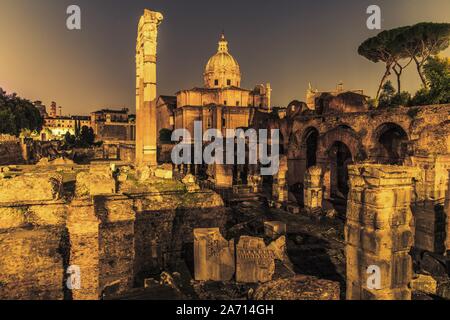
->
90;108;136;141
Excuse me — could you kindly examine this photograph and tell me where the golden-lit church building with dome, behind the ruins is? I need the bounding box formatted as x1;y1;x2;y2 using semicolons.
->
157;35;272;141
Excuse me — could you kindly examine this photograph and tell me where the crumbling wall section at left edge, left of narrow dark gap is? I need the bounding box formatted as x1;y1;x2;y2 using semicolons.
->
0;174;67;300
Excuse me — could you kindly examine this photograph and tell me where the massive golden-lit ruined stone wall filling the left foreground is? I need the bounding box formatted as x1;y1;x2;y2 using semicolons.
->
0;166;227;300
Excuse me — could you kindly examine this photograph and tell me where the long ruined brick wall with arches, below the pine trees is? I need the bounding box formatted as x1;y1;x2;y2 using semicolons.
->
282;104;450;195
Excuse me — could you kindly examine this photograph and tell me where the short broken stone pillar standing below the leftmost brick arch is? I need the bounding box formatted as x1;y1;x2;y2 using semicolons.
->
303;167;323;213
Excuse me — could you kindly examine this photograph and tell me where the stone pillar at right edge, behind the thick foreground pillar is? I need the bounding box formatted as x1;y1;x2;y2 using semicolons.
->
408;155;450;254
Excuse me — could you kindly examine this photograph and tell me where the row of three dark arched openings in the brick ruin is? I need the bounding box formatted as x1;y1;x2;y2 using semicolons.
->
289;123;409;215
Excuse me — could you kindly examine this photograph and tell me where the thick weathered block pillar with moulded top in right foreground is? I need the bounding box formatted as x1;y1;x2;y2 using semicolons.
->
345;164;417;300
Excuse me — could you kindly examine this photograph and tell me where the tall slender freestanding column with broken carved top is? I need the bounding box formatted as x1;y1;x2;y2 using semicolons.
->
136;10;163;166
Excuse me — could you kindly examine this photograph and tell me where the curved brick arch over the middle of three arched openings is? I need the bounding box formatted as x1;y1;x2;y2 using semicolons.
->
318;125;367;162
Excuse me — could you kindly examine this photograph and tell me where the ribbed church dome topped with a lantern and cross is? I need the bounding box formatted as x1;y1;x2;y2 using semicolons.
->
204;34;241;88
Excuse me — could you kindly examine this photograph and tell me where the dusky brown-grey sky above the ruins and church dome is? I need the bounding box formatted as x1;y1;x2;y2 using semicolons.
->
0;0;450;114
